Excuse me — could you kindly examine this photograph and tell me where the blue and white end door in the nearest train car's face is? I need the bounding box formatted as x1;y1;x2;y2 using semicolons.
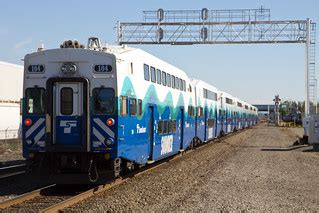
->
53;82;85;148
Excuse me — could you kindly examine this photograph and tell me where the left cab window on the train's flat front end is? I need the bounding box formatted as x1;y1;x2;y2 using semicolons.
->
26;88;45;114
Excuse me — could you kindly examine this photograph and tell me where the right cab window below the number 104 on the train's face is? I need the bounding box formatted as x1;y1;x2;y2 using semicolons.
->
93;88;115;115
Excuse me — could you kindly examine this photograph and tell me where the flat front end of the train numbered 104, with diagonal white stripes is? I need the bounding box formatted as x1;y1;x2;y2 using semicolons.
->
22;38;121;184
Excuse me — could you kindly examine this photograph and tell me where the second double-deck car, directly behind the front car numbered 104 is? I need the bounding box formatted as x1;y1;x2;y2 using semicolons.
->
191;79;221;142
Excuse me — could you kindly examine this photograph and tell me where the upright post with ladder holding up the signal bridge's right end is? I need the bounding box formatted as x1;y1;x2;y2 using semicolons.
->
305;18;310;117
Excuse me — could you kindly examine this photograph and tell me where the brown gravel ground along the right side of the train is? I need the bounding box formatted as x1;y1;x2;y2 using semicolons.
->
66;125;319;212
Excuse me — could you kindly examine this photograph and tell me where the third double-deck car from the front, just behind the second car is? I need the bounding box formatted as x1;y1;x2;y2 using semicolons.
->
219;91;235;134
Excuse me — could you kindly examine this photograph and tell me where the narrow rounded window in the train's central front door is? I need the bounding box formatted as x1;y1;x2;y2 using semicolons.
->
60;87;73;115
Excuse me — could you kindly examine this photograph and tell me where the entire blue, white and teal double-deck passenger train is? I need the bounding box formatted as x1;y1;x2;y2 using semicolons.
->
21;38;257;183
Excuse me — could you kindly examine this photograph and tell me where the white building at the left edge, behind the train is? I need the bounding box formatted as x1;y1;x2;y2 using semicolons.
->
0;61;23;140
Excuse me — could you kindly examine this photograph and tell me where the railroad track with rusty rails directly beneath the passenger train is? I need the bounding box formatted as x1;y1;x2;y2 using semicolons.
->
0;129;252;212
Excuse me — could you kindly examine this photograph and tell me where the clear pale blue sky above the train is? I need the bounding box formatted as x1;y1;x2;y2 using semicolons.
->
0;0;319;104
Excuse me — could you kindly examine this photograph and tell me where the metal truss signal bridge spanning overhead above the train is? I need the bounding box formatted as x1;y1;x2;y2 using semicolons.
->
117;7;317;115
